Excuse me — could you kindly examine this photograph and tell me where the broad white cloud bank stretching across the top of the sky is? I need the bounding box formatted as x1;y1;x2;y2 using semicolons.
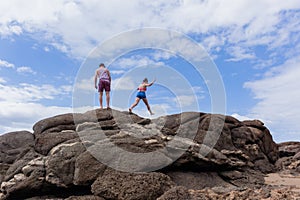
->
0;0;300;57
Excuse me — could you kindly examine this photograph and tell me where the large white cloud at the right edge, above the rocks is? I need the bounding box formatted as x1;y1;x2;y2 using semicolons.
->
244;57;300;141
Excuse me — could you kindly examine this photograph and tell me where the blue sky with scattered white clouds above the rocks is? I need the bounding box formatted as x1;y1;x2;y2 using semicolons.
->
0;0;300;142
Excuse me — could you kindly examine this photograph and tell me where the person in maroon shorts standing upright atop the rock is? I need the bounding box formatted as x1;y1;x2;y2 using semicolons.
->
95;63;111;109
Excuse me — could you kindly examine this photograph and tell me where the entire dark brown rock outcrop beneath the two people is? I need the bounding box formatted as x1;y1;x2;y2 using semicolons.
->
0;109;300;200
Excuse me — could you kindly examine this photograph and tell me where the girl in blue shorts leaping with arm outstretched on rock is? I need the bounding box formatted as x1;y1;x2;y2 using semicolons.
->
129;78;155;115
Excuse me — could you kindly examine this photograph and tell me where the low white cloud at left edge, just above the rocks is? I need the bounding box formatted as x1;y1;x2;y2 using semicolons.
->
0;82;72;134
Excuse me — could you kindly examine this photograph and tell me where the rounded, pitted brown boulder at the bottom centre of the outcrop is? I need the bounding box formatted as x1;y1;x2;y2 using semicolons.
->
92;170;174;199
